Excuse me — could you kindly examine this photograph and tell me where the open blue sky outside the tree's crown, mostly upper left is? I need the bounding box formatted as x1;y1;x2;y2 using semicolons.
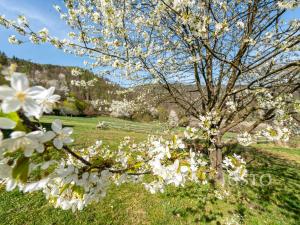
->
0;0;300;66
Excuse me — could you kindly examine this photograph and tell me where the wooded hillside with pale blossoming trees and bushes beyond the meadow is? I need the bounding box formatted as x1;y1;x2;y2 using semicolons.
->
0;52;175;120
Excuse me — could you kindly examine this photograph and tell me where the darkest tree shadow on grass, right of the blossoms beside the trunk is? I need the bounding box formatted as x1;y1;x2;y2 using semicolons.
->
246;148;300;222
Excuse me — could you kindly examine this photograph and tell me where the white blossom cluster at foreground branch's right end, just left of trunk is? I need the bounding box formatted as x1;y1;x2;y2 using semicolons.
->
145;139;207;193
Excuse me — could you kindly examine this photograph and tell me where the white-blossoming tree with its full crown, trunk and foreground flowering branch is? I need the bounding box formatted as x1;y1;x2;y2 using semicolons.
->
0;0;300;209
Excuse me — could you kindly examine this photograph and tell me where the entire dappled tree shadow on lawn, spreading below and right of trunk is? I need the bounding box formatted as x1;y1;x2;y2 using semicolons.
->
161;146;300;224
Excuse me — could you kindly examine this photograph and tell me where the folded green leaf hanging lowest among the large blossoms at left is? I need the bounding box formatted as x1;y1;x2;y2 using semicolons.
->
12;156;29;183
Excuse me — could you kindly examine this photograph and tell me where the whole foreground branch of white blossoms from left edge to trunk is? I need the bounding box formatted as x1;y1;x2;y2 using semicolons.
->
0;68;245;211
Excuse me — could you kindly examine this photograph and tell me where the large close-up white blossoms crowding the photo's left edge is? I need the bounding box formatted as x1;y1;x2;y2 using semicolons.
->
0;67;73;203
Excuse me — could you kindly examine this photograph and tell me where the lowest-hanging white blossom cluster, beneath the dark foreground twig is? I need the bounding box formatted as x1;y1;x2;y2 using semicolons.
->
43;161;112;211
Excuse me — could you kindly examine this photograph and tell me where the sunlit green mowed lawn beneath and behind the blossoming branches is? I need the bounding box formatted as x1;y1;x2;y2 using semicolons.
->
0;116;300;225
